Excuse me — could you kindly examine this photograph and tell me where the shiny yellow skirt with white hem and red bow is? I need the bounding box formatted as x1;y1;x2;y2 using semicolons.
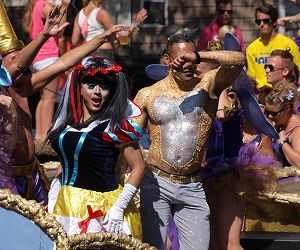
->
53;186;142;239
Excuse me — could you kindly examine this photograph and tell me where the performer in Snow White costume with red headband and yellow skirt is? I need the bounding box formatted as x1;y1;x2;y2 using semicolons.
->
48;57;145;238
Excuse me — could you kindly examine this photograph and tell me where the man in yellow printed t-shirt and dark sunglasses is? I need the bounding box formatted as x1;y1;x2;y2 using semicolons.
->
246;4;300;89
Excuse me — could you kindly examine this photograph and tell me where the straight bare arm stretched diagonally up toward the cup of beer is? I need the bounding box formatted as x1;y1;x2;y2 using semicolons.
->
20;24;124;96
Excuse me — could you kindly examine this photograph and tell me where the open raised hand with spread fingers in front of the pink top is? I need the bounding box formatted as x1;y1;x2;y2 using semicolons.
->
42;5;69;37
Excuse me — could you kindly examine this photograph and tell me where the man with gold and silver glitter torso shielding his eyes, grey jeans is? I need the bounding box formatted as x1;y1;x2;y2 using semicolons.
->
134;33;245;250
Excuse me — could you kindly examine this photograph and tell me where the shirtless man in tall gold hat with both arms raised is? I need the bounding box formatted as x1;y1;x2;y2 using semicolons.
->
0;2;122;205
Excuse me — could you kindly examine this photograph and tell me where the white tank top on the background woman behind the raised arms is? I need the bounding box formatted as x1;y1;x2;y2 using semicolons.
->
78;8;105;42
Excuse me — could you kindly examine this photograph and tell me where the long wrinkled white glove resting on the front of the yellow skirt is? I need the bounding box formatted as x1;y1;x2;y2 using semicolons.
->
102;183;137;233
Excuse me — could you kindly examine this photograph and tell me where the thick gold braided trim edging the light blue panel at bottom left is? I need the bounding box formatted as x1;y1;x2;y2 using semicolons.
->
0;189;70;250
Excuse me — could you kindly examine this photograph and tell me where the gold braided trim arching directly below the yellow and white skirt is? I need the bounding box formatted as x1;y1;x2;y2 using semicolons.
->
69;232;157;250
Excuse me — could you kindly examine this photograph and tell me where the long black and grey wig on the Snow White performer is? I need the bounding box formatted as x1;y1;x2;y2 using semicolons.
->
48;57;129;142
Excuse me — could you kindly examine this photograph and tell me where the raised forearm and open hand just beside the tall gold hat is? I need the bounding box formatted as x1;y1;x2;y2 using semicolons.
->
7;6;68;79
